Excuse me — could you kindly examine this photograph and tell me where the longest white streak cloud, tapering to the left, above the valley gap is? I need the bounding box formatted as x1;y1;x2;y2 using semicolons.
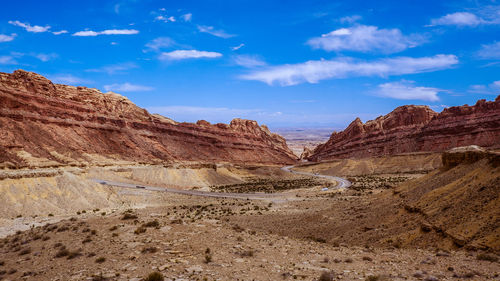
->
240;55;458;86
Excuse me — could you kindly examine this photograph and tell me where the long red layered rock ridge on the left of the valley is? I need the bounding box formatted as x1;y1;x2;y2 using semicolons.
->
0;70;296;168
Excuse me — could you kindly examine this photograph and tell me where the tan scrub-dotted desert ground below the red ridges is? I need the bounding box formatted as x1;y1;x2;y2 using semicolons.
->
0;154;500;280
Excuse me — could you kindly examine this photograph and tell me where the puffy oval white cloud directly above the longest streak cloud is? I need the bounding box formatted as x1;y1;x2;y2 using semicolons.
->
307;25;425;54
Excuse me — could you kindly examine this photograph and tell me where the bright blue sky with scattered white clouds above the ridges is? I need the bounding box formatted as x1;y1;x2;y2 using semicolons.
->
0;0;500;128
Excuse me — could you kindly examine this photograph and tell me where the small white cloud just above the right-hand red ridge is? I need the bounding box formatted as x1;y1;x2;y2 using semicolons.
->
376;80;443;102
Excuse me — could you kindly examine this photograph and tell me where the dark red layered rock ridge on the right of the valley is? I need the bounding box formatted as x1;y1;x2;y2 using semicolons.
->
306;96;500;161
